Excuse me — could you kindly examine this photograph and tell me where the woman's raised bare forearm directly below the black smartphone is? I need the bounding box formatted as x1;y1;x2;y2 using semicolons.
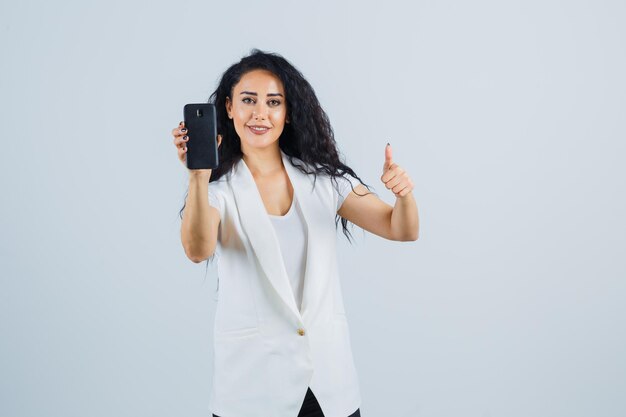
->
180;170;220;263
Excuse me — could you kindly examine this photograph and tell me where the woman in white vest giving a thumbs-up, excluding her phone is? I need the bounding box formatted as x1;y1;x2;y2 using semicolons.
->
172;49;419;417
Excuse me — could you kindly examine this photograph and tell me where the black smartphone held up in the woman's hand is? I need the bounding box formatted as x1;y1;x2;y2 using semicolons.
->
183;103;219;169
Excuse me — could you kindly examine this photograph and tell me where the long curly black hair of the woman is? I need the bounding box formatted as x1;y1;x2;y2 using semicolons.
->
179;48;375;241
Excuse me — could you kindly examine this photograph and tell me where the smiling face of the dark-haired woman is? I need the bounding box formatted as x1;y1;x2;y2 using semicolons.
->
226;70;287;154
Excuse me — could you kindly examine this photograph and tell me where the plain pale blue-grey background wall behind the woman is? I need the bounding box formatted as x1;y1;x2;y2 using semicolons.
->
0;0;626;417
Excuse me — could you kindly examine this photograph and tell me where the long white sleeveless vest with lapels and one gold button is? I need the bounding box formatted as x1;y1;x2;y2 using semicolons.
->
209;150;361;417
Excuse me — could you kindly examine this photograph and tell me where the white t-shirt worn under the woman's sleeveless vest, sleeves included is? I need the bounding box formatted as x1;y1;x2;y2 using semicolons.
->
209;174;360;309
